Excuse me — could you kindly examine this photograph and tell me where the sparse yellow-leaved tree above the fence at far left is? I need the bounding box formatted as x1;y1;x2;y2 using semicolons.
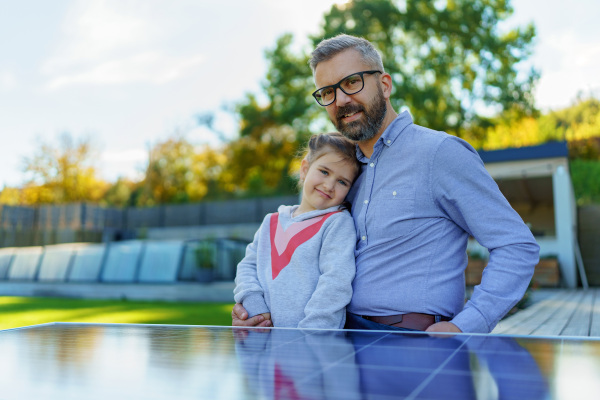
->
21;133;108;204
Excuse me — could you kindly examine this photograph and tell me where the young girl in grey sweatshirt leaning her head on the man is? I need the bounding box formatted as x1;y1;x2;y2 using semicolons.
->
233;133;359;329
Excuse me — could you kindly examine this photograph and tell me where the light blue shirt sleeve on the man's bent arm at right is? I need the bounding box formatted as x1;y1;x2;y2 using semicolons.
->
432;138;539;333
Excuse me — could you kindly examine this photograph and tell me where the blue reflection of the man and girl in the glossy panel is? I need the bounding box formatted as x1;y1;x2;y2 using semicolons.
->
235;330;550;399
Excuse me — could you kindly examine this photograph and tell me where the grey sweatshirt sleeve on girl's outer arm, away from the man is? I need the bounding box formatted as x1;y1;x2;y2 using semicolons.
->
233;214;271;317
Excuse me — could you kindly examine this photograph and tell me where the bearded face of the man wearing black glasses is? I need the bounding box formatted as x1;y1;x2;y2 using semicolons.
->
315;50;387;141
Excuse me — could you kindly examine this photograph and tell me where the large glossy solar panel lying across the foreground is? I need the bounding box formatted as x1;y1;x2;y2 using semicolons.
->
0;323;600;400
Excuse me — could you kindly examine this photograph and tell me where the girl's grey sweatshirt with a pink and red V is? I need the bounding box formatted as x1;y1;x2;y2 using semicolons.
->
233;205;356;329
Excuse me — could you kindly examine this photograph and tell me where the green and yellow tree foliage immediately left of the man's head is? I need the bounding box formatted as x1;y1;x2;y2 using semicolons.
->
227;34;321;196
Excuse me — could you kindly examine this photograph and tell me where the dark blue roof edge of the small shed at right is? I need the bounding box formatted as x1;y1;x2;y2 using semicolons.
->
477;141;569;163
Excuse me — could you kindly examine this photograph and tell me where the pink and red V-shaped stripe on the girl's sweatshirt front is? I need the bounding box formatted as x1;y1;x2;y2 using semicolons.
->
270;211;339;279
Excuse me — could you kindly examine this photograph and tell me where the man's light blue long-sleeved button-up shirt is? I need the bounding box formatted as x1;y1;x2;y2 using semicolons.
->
348;112;539;333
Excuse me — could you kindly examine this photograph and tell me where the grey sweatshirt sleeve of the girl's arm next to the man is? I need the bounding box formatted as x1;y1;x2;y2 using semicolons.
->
298;211;356;329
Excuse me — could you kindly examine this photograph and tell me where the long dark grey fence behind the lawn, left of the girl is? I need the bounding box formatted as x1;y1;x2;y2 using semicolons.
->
0;196;298;247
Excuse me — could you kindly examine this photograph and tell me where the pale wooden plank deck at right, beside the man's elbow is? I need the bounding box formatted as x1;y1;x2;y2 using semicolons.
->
492;288;600;338
